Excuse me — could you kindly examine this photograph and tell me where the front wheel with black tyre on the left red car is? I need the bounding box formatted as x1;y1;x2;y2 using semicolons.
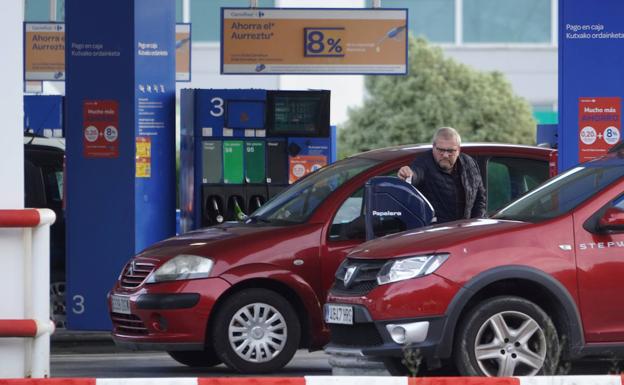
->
212;289;301;373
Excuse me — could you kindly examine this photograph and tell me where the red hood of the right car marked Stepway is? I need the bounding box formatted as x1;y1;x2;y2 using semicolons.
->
348;219;529;259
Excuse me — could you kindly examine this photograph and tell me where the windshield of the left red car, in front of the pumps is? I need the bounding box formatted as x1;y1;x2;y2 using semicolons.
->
248;158;379;223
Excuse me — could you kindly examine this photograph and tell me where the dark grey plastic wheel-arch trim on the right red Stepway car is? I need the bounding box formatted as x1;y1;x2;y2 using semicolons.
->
438;265;584;358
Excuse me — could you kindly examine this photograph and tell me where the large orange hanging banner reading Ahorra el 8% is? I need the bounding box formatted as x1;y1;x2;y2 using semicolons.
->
221;8;407;74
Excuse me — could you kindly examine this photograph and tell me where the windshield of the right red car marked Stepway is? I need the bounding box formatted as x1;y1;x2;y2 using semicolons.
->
492;163;624;223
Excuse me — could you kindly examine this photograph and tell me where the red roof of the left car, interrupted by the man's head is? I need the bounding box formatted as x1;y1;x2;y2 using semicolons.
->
352;142;557;161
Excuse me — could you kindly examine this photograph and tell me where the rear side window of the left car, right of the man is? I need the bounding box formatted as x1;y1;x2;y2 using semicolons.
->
486;157;549;214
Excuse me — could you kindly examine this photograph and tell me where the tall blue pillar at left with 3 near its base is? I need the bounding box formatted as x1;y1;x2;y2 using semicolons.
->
65;0;175;330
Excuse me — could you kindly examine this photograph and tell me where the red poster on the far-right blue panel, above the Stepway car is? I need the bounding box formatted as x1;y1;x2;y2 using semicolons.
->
578;97;622;162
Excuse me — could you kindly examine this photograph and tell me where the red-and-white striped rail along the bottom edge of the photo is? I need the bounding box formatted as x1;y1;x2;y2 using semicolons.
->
0;375;624;385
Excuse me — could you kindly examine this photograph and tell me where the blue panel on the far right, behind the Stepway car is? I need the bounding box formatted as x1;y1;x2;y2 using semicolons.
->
557;0;624;170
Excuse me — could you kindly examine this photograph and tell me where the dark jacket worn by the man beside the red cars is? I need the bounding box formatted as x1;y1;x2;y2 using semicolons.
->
412;150;487;219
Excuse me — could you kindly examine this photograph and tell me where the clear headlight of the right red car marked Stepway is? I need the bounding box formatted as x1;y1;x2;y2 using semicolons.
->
377;254;449;285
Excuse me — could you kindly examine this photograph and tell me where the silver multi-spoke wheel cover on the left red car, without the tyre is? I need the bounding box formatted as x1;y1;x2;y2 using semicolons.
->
228;303;288;363
